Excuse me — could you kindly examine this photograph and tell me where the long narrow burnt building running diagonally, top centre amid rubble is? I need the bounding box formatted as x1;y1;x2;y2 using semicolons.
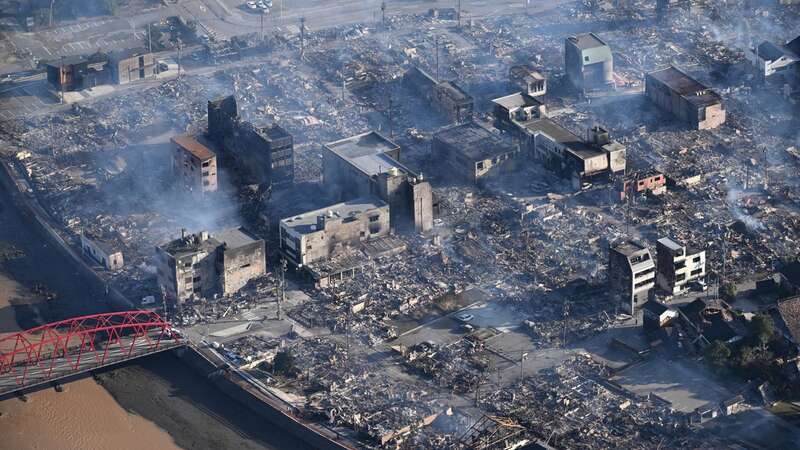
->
403;67;475;123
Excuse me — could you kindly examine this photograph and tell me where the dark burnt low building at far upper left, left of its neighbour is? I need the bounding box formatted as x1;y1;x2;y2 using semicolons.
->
45;52;110;91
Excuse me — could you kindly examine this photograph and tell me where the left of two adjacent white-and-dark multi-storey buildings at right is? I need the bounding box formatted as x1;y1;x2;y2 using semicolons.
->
608;241;656;314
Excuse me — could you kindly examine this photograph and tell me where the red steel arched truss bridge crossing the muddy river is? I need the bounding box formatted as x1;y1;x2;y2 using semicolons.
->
0;311;184;396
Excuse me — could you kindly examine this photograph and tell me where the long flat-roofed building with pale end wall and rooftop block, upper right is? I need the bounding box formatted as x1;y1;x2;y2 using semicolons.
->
518;119;626;189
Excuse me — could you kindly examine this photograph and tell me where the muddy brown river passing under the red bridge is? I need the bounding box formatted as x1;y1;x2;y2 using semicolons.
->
0;171;307;450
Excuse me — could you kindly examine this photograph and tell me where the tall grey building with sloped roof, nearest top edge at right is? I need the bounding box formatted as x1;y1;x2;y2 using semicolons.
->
564;33;614;91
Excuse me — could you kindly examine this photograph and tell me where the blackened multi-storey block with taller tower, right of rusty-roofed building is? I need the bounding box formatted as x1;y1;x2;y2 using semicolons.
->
208;95;294;186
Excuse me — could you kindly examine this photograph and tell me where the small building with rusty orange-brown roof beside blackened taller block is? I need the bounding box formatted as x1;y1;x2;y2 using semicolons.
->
172;135;217;193
